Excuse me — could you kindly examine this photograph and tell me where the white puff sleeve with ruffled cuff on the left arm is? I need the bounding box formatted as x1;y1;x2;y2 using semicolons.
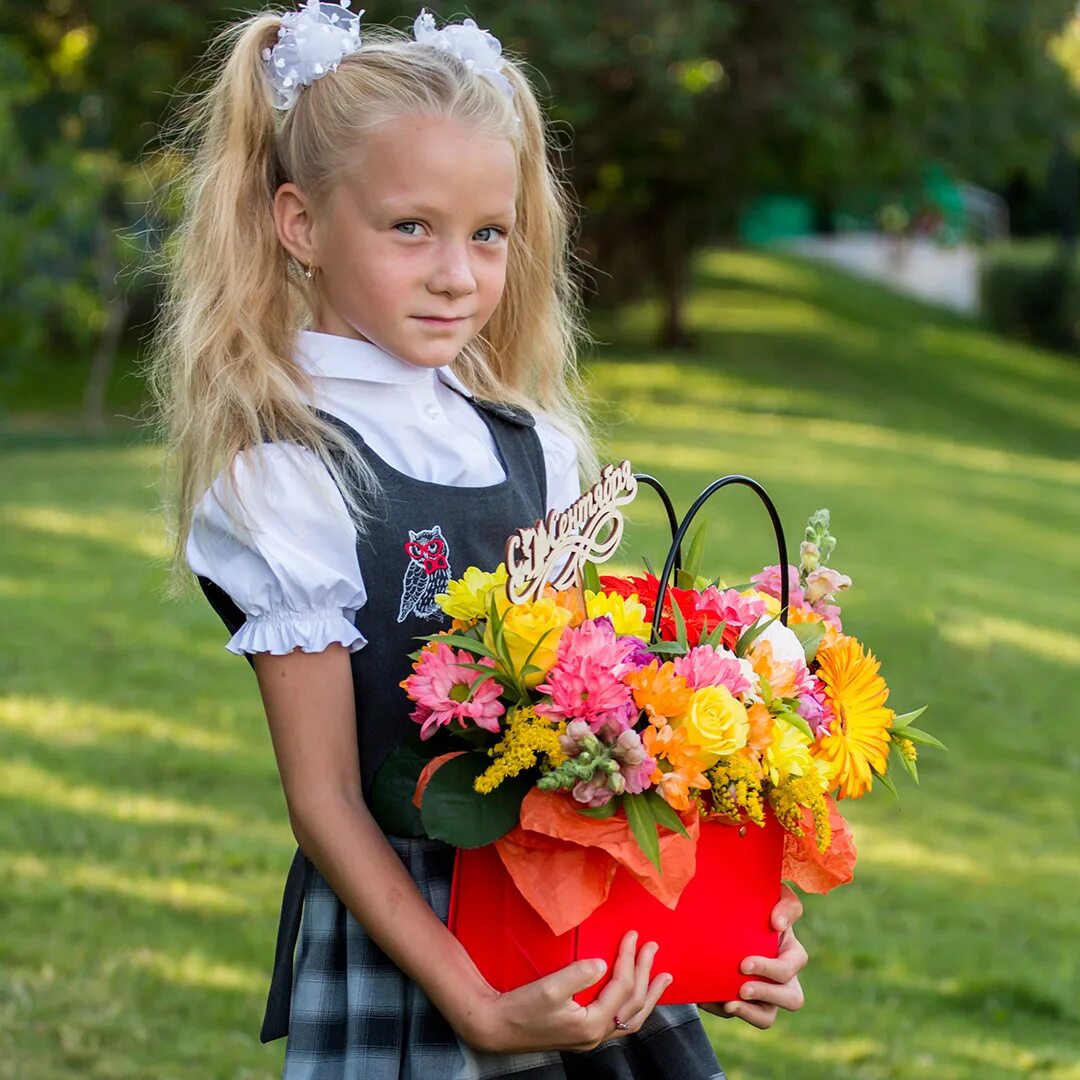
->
186;443;367;656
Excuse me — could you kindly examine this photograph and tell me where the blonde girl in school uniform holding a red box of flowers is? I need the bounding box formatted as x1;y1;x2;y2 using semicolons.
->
152;0;806;1080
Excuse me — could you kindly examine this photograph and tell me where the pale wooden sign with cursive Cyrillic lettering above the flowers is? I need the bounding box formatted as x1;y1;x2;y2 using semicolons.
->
505;461;637;604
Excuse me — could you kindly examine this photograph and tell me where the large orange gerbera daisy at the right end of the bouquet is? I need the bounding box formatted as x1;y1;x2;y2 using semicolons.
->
812;637;895;799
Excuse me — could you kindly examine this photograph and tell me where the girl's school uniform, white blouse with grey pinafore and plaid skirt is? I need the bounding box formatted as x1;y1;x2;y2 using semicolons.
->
187;332;724;1080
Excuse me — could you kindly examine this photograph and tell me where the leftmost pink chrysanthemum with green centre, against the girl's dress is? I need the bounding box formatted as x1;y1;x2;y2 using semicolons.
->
402;642;505;739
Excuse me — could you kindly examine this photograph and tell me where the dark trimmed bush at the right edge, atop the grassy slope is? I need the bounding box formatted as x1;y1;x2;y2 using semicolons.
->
978;240;1080;352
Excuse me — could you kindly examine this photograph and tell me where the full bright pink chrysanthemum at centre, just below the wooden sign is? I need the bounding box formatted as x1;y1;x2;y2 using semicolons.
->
536;619;637;737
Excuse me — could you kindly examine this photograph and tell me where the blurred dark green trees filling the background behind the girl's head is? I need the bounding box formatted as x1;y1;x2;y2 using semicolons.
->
0;0;1076;388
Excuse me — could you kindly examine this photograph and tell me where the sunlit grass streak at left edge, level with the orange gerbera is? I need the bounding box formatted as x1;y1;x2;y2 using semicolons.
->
0;696;251;754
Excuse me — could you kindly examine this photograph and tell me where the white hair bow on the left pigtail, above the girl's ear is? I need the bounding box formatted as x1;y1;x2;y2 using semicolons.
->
262;0;364;109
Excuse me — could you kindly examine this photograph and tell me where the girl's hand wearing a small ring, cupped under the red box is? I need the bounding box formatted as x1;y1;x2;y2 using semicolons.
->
460;930;672;1053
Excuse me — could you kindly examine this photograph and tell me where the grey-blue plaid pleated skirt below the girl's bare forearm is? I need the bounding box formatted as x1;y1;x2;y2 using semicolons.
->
274;837;724;1080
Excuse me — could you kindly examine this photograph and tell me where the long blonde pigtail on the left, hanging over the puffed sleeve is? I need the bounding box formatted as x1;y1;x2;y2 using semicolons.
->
146;14;376;593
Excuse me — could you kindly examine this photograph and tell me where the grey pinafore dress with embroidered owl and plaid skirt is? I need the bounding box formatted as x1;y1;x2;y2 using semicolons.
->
200;401;724;1080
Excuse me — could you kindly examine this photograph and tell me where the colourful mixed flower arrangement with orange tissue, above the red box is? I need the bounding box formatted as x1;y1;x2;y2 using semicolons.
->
393;510;941;898
